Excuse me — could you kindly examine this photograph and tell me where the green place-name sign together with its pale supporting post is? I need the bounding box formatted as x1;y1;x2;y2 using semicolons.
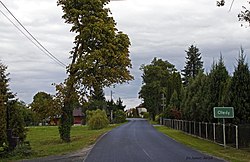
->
214;107;234;147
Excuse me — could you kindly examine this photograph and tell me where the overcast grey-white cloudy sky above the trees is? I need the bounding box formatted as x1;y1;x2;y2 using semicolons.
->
0;0;250;108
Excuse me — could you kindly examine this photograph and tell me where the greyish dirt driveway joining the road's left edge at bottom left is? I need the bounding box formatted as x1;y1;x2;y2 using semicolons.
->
19;145;94;162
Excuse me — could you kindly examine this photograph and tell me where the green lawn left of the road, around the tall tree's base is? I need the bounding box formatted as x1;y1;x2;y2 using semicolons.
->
0;124;119;161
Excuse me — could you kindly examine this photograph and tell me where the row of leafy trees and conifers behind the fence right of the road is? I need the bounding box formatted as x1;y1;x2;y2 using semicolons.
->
139;45;250;124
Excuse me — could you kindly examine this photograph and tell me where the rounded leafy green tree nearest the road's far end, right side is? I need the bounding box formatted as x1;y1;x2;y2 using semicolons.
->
139;58;182;119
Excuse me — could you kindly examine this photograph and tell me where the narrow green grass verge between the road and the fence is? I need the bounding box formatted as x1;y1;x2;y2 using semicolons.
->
156;126;250;162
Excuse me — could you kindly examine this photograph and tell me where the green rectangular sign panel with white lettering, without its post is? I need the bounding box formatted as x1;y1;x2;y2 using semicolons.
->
214;107;234;118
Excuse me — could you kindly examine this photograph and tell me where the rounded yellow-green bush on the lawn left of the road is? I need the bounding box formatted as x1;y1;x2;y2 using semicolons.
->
87;109;109;130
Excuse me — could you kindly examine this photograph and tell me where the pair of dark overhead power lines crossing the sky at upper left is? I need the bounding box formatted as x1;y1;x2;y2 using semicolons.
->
0;1;66;68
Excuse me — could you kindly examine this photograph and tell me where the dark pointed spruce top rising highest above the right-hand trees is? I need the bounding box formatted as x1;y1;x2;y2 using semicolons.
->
182;45;203;85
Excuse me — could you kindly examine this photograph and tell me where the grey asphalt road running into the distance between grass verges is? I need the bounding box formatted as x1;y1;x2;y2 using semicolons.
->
85;119;226;162
